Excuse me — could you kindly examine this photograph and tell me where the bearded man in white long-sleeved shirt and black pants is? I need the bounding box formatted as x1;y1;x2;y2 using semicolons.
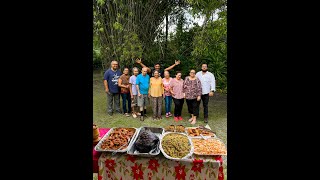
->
196;64;216;123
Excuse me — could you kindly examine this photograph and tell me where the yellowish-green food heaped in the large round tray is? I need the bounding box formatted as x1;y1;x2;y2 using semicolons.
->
161;133;191;158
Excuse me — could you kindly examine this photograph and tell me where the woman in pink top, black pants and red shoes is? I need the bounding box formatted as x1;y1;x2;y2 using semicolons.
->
170;71;184;121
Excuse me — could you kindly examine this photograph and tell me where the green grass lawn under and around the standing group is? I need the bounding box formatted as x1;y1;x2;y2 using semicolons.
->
93;71;227;179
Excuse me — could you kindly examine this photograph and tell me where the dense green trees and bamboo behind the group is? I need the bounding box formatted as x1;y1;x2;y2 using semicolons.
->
93;0;227;92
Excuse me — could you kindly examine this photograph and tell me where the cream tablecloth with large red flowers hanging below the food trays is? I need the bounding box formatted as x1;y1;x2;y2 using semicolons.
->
98;152;224;180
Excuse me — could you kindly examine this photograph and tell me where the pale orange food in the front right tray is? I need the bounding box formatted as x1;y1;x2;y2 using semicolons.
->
192;138;227;155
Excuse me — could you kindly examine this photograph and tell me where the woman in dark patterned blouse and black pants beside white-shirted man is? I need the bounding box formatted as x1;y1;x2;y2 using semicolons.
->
183;69;202;124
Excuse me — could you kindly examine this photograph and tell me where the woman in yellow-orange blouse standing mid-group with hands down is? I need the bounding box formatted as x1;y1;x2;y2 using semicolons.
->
149;70;164;120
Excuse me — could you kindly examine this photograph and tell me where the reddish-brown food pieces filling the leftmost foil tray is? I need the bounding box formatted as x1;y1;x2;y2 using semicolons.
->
100;128;135;150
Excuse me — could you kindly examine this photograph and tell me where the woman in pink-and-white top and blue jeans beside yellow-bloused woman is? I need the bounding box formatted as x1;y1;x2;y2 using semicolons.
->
162;71;172;118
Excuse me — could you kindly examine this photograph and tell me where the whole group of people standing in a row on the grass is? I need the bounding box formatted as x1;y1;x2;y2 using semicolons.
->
104;59;216;124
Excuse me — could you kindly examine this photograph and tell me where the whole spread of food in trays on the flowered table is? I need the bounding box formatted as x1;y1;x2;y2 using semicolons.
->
93;125;227;159
